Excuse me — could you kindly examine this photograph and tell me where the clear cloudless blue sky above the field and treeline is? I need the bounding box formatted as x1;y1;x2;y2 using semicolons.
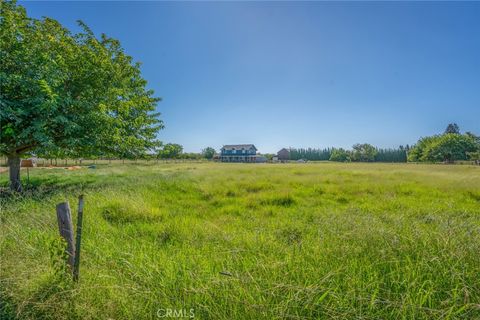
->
20;2;480;152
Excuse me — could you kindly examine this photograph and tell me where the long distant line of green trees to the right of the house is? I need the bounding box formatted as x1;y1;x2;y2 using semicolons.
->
290;123;480;163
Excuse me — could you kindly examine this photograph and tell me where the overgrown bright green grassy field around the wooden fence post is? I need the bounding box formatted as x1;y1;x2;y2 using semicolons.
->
0;163;480;320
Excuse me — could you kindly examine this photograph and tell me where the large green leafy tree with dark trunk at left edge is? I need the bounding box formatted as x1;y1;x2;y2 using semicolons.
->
0;1;163;191
